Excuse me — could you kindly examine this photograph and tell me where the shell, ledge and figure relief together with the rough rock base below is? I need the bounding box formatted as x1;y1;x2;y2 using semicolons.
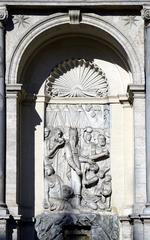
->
36;59;119;240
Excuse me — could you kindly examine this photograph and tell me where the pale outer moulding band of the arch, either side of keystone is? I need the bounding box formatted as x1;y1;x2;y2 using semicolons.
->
6;13;144;84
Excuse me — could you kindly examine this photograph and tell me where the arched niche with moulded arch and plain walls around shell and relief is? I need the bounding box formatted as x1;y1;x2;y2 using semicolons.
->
7;14;135;219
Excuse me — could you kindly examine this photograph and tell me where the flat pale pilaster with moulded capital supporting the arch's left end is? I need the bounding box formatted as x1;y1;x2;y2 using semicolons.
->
6;84;22;215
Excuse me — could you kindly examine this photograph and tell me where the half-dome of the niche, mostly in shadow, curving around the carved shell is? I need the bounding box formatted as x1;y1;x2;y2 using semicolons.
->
20;33;133;96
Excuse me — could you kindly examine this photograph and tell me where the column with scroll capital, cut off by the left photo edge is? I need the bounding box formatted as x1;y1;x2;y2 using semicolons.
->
0;6;8;215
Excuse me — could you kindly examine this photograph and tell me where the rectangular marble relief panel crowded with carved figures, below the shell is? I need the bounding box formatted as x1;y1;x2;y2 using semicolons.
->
44;104;112;211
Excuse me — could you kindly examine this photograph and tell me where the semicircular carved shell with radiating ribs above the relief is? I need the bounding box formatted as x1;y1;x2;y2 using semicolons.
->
46;59;108;97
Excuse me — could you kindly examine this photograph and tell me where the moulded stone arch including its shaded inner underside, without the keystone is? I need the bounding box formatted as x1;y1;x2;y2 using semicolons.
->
6;13;144;84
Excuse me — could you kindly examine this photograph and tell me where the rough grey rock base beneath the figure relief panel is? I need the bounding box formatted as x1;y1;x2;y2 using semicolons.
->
35;213;119;240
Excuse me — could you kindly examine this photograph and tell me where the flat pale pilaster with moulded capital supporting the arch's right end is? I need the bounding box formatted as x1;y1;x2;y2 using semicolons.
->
128;85;146;214
